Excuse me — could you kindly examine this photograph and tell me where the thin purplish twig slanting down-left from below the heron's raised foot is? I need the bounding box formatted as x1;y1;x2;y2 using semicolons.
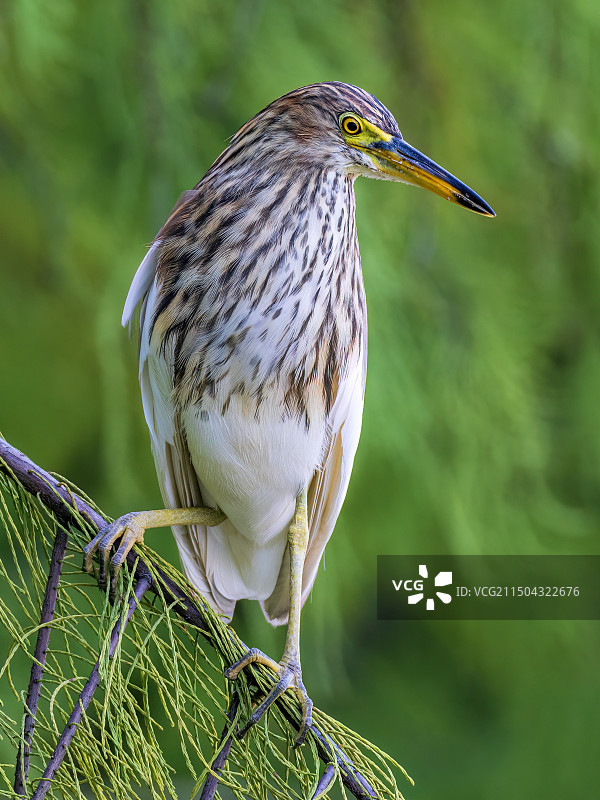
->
31;575;152;800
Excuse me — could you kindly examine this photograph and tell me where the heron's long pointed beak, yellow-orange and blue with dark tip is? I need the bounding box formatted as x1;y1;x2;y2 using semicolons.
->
368;136;496;217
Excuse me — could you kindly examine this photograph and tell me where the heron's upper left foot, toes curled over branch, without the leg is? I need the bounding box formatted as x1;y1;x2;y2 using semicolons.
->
83;512;146;603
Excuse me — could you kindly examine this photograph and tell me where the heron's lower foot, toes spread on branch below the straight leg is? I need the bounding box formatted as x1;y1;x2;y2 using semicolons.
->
225;647;313;747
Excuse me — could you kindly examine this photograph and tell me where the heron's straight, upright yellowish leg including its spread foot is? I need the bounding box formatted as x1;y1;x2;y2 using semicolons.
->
225;489;312;745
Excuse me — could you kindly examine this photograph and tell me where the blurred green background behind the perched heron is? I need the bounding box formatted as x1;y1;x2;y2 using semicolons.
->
0;0;600;800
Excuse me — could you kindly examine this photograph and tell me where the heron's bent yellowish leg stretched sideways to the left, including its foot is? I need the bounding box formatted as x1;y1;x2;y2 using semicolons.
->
83;508;225;599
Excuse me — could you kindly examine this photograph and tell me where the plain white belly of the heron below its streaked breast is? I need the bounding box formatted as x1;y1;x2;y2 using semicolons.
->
182;397;327;600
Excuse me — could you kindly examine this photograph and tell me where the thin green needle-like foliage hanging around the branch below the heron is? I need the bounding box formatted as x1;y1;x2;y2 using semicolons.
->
0;468;410;800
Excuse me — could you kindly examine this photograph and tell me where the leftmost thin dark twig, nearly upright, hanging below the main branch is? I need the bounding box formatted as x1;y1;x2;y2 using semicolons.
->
14;523;67;797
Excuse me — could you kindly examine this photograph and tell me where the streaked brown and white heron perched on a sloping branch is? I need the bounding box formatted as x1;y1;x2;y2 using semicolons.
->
84;81;495;745
